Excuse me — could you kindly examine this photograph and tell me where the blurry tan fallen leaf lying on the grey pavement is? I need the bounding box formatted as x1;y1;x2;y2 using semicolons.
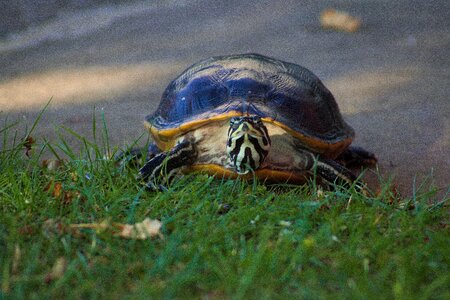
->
320;8;361;32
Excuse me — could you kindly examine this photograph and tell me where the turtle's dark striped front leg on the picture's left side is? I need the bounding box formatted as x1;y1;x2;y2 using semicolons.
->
139;141;197;190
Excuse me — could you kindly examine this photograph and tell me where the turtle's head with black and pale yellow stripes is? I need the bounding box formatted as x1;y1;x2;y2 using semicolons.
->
227;116;270;174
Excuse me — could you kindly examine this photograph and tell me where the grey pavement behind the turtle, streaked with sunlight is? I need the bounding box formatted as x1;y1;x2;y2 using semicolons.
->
0;0;450;195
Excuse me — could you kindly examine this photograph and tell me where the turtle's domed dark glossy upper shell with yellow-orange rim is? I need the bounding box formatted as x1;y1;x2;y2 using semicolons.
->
145;54;354;153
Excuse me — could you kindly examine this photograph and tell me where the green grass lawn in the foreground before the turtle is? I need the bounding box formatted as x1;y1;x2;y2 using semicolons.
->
0;114;450;299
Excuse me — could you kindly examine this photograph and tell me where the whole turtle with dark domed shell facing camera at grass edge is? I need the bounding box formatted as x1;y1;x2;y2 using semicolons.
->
131;53;377;190
